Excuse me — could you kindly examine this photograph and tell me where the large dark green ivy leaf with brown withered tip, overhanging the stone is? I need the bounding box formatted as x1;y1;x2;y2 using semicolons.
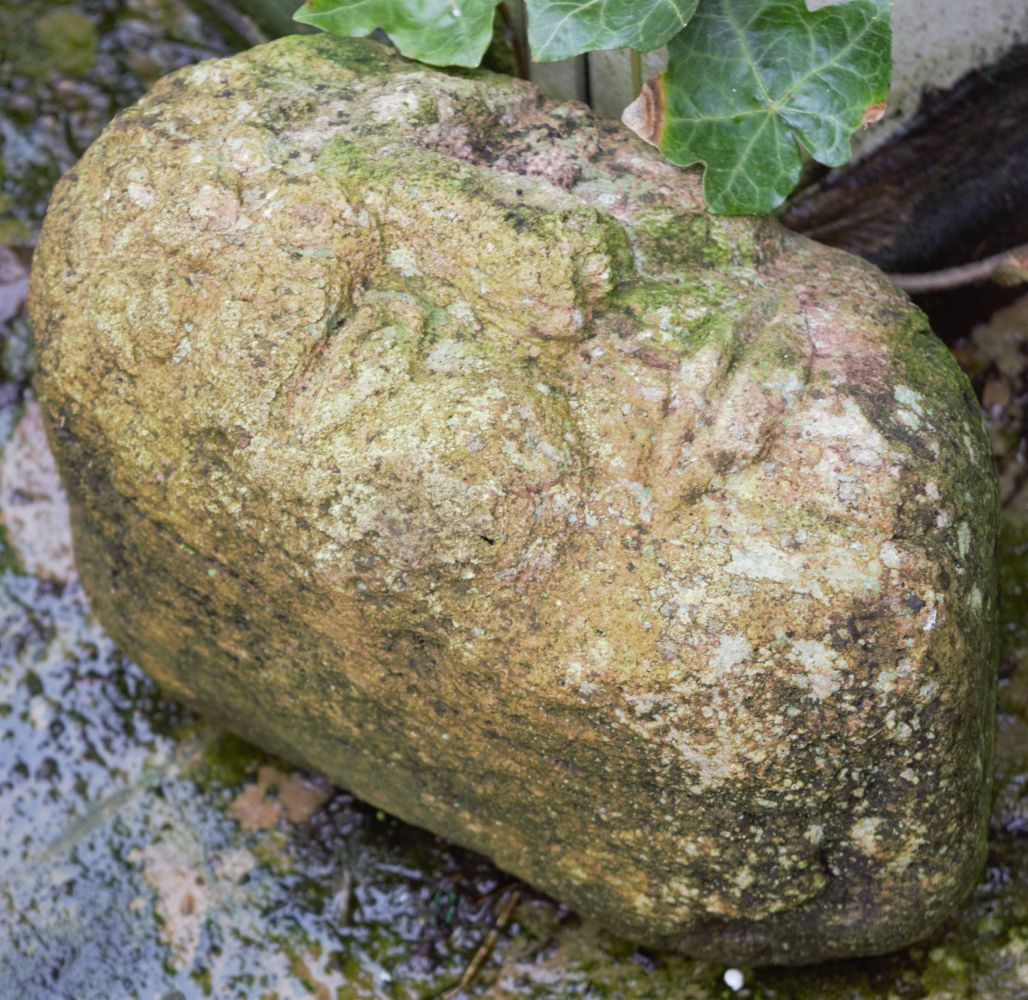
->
624;0;891;215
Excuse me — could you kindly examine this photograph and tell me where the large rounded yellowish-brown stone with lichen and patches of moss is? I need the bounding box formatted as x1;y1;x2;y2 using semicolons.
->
30;37;996;963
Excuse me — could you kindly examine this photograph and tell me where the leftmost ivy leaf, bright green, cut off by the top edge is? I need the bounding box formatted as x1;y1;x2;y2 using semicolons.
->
293;0;500;66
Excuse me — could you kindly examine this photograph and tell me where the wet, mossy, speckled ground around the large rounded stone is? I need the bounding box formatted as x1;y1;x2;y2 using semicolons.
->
0;0;1028;1000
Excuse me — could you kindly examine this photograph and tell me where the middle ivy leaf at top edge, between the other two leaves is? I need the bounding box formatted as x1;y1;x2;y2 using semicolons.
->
525;0;699;63
